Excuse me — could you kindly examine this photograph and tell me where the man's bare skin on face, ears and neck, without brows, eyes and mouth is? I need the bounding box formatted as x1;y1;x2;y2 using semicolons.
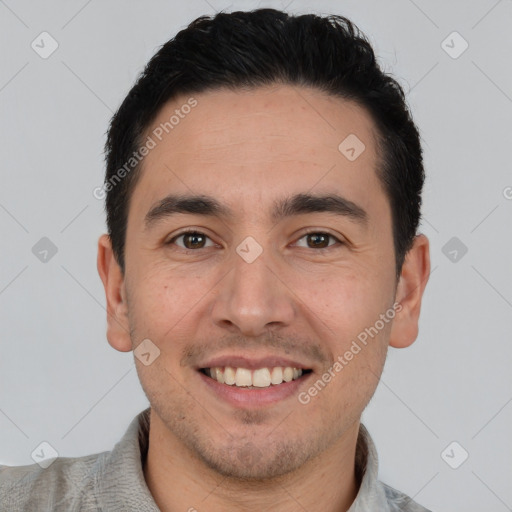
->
98;85;430;511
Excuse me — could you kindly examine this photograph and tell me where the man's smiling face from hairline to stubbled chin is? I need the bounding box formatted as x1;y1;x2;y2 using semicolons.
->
98;86;426;479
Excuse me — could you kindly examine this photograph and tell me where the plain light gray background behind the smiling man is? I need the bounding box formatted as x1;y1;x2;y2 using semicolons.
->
0;0;512;512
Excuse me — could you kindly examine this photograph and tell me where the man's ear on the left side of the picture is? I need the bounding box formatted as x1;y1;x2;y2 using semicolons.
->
97;234;132;352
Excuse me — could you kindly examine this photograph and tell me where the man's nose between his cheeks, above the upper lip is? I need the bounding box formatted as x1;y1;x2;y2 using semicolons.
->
212;243;296;337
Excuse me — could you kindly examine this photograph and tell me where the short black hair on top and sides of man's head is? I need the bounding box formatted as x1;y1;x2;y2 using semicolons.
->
104;9;425;276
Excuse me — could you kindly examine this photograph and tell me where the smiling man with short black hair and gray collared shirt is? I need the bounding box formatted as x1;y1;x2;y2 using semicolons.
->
0;9;430;512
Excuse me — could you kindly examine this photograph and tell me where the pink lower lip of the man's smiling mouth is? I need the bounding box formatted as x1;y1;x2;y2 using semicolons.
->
197;372;312;407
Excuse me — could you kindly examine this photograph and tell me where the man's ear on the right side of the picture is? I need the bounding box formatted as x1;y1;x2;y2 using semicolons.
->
389;235;430;348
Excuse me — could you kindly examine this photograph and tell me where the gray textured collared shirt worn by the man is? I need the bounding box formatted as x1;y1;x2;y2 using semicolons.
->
0;408;429;512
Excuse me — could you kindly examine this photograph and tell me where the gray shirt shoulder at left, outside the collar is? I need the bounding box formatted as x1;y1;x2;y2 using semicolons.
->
0;452;109;512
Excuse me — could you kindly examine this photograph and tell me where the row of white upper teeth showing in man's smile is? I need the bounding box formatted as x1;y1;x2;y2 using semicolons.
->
206;366;302;388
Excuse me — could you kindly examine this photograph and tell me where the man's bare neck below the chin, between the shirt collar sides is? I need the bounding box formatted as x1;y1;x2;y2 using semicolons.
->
144;409;360;512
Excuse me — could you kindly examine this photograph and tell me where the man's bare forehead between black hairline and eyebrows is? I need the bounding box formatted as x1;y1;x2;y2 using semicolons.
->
130;85;386;225
